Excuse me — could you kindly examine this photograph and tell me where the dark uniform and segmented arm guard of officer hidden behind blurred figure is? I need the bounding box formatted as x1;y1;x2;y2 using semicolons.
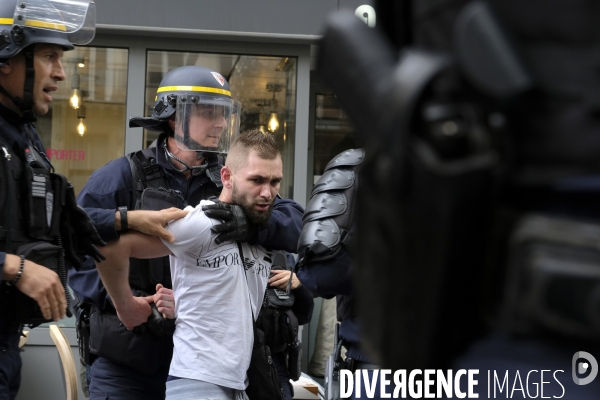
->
297;149;392;398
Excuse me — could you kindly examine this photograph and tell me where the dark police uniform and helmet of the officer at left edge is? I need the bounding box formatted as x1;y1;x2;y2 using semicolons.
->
0;0;98;400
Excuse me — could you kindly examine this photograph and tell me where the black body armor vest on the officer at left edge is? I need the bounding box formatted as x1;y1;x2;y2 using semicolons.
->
0;129;70;325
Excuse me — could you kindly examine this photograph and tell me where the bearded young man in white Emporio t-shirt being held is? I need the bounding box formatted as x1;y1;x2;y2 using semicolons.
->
97;130;283;400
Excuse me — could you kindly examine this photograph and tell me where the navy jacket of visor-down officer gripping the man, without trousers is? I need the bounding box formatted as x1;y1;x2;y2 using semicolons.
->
70;133;304;308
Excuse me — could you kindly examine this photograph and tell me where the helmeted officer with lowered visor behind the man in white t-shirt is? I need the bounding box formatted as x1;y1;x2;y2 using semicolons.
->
71;66;303;400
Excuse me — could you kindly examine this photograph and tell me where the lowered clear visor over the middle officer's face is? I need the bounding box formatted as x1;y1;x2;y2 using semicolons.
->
175;95;241;154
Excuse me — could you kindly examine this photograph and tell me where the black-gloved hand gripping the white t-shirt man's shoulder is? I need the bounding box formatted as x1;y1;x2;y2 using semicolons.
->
202;202;258;244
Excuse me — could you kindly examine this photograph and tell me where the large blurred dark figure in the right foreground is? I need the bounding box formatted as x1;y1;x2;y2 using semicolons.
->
319;0;600;399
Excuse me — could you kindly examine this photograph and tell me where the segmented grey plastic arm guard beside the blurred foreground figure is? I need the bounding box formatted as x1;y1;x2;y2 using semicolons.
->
298;149;365;265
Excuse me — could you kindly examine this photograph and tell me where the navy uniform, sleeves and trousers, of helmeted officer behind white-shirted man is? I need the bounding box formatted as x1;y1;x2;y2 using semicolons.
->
70;134;304;399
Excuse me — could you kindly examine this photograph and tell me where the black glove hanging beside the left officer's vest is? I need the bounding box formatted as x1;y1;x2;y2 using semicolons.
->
60;184;106;269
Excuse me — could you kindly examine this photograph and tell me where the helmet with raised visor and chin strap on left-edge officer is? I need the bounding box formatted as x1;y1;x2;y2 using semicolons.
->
0;0;96;122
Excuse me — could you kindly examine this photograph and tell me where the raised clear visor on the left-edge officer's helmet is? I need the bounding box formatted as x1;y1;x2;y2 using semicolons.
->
13;0;96;45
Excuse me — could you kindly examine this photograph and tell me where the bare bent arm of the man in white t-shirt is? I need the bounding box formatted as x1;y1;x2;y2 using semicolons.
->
96;232;171;329
